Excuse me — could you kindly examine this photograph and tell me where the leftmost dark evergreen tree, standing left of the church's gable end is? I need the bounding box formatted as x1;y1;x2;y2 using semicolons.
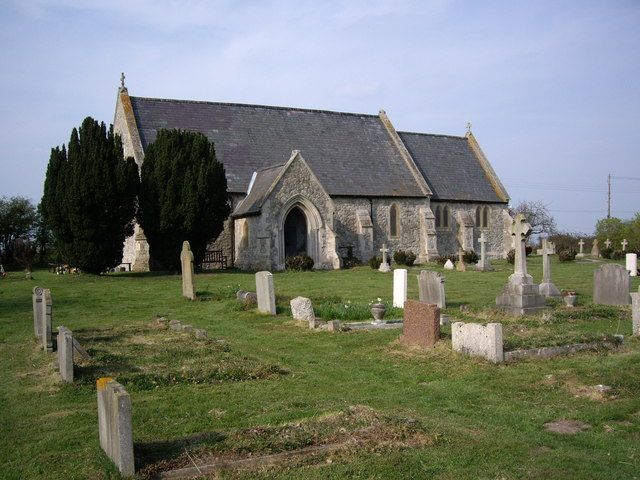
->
42;117;140;273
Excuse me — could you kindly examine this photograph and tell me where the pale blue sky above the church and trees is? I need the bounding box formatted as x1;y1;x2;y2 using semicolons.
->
0;0;640;233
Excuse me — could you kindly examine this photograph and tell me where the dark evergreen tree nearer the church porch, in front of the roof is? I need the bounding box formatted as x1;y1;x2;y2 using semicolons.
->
137;130;231;268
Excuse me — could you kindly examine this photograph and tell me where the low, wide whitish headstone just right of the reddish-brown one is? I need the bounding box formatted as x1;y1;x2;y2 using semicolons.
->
451;322;504;363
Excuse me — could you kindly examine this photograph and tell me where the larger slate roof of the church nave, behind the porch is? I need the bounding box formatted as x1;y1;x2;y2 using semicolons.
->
130;97;424;197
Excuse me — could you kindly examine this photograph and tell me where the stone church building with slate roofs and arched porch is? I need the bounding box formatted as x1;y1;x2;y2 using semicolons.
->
114;82;511;271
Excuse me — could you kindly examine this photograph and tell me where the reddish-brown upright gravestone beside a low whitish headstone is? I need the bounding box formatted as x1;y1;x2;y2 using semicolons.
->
400;300;440;348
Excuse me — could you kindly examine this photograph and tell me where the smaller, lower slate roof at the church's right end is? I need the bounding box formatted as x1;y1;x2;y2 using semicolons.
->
398;132;504;203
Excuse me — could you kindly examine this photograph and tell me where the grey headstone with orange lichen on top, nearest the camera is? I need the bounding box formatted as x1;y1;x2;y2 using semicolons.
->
96;377;135;476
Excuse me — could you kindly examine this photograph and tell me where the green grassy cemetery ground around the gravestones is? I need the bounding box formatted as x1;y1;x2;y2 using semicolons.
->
0;257;640;479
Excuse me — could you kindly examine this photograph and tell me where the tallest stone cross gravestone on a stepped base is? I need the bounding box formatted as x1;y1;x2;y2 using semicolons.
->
496;213;545;315
